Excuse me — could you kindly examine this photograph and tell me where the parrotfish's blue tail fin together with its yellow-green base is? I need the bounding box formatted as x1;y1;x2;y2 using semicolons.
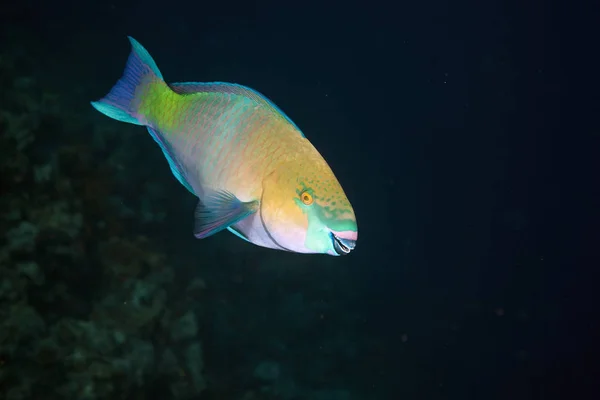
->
91;36;170;125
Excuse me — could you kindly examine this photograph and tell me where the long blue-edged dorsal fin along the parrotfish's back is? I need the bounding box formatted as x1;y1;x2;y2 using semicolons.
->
169;82;304;137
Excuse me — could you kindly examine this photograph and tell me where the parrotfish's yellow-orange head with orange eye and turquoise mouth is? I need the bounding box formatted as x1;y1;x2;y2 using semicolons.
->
260;160;358;256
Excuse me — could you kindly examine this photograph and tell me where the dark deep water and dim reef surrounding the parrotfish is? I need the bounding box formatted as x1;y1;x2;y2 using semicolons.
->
0;0;600;400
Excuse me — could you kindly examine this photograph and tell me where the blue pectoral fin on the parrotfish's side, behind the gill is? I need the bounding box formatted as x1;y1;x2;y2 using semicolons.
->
194;190;258;239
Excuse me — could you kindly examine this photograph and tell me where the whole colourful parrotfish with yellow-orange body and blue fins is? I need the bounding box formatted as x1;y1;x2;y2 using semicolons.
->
91;37;358;255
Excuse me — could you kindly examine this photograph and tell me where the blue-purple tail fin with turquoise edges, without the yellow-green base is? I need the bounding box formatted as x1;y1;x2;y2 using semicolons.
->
92;36;163;125
